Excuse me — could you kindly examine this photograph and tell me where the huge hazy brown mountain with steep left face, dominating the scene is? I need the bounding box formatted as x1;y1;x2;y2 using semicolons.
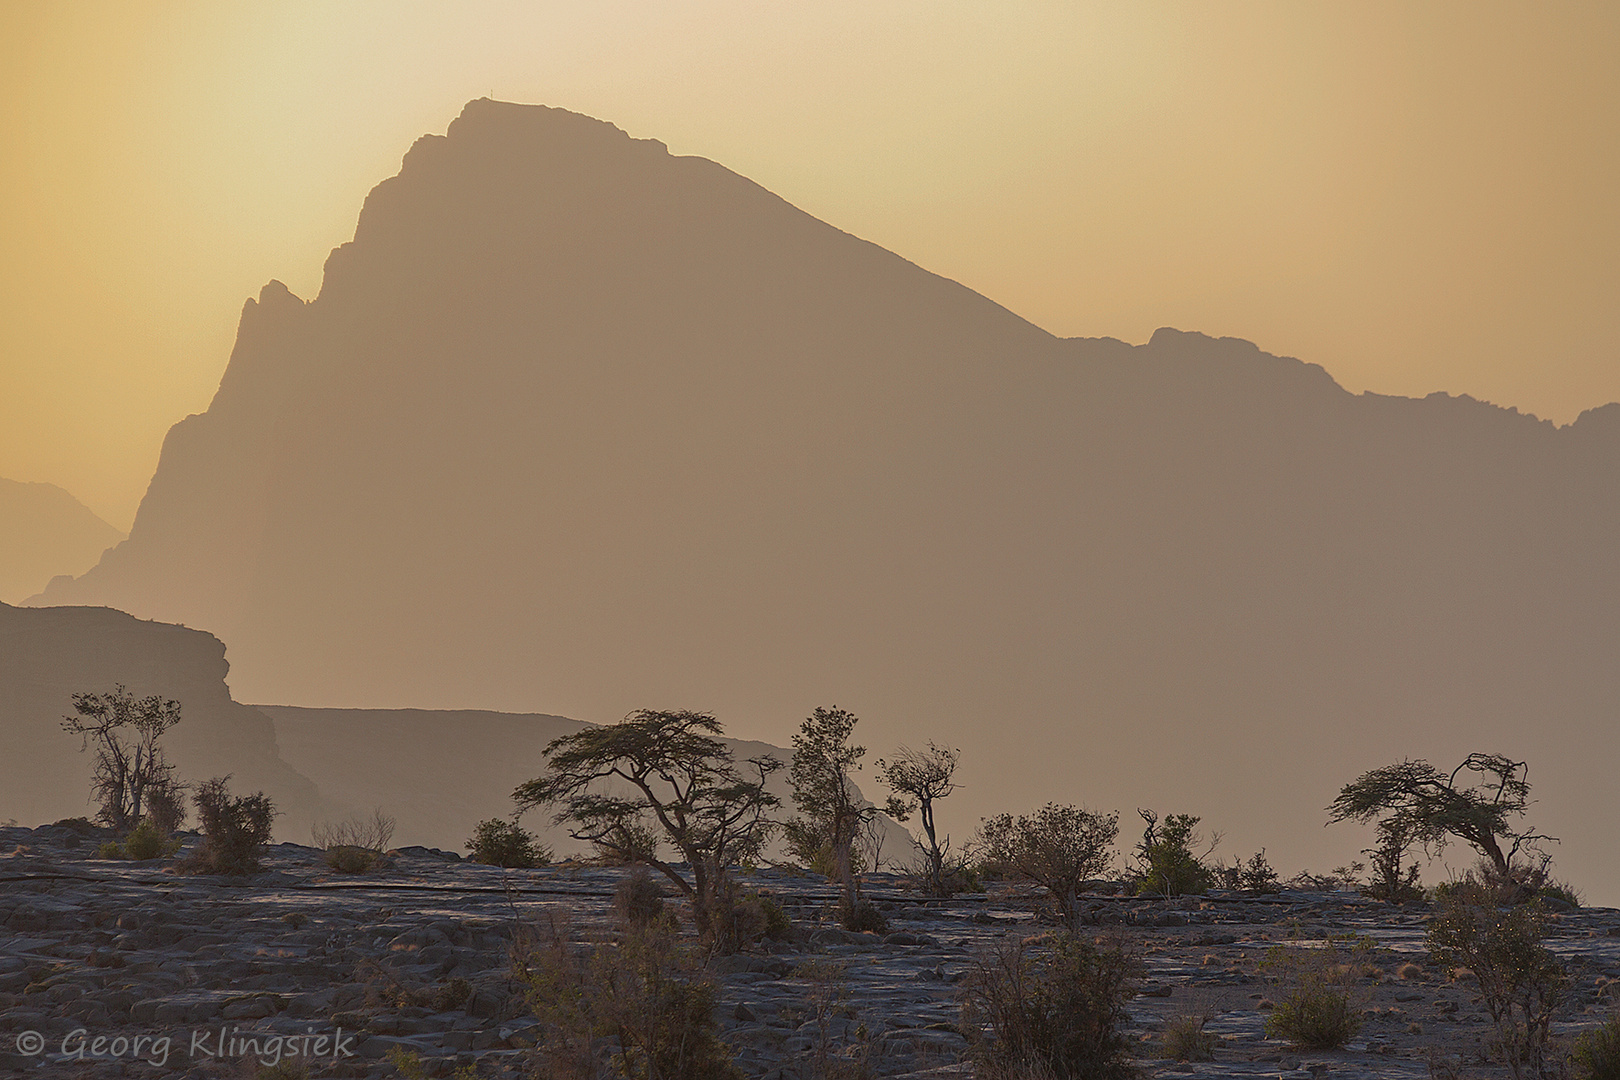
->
34;100;1620;900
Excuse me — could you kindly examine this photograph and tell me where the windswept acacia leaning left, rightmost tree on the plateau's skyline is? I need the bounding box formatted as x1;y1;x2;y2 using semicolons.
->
1327;753;1554;882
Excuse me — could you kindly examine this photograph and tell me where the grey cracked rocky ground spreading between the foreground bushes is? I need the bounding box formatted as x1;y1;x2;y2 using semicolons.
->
0;826;1620;1080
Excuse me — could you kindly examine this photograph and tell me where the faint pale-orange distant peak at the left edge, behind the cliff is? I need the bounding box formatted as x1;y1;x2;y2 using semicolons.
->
0;478;123;604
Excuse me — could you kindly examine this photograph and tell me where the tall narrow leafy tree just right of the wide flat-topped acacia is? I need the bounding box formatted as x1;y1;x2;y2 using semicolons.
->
786;706;878;915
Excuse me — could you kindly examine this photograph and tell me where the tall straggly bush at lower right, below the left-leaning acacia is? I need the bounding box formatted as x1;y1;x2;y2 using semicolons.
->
1429;881;1570;1077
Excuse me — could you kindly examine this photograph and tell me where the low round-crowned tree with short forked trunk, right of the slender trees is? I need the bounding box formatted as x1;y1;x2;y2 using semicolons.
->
977;803;1119;928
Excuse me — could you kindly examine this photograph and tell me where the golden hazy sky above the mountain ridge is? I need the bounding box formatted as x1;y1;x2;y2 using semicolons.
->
0;0;1620;528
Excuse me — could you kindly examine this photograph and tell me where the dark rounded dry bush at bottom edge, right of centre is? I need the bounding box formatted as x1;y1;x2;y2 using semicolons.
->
961;931;1137;1080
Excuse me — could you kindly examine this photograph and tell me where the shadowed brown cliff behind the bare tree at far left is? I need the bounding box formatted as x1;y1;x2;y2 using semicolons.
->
0;604;328;842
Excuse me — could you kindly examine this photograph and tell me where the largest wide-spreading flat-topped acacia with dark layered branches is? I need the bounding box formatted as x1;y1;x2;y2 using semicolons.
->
512;709;782;933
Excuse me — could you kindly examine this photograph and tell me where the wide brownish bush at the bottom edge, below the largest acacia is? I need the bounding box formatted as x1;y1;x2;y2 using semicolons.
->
512;923;742;1080
